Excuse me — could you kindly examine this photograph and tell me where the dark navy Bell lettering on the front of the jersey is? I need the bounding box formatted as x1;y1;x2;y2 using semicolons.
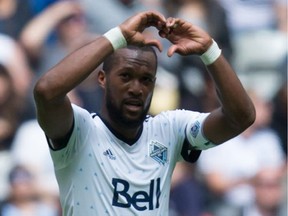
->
112;178;161;211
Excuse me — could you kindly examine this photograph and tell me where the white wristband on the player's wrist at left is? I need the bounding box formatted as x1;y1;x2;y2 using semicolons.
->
103;26;127;51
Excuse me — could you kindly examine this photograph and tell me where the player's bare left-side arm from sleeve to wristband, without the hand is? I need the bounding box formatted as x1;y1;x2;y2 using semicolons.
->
34;37;113;140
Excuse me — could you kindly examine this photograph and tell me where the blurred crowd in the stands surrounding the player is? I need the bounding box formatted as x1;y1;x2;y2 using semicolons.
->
0;0;287;216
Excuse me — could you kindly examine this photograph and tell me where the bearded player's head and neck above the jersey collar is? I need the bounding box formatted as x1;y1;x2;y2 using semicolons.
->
98;49;157;139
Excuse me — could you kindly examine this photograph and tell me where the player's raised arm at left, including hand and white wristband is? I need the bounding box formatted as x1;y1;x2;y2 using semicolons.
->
34;12;165;149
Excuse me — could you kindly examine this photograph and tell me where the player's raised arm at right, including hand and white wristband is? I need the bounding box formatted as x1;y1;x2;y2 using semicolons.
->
160;18;255;144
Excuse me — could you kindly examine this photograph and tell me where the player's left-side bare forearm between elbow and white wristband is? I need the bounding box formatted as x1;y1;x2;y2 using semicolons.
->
35;37;113;101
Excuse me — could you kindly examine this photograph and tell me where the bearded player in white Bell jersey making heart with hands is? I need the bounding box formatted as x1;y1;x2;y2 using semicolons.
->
34;11;255;216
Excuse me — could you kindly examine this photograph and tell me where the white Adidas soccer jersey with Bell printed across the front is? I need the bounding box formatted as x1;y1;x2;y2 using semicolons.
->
50;105;207;216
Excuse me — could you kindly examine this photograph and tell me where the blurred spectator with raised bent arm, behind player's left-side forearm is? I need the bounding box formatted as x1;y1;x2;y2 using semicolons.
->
21;1;102;112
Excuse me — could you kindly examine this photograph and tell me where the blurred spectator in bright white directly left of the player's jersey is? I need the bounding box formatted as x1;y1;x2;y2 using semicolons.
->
10;119;59;202
